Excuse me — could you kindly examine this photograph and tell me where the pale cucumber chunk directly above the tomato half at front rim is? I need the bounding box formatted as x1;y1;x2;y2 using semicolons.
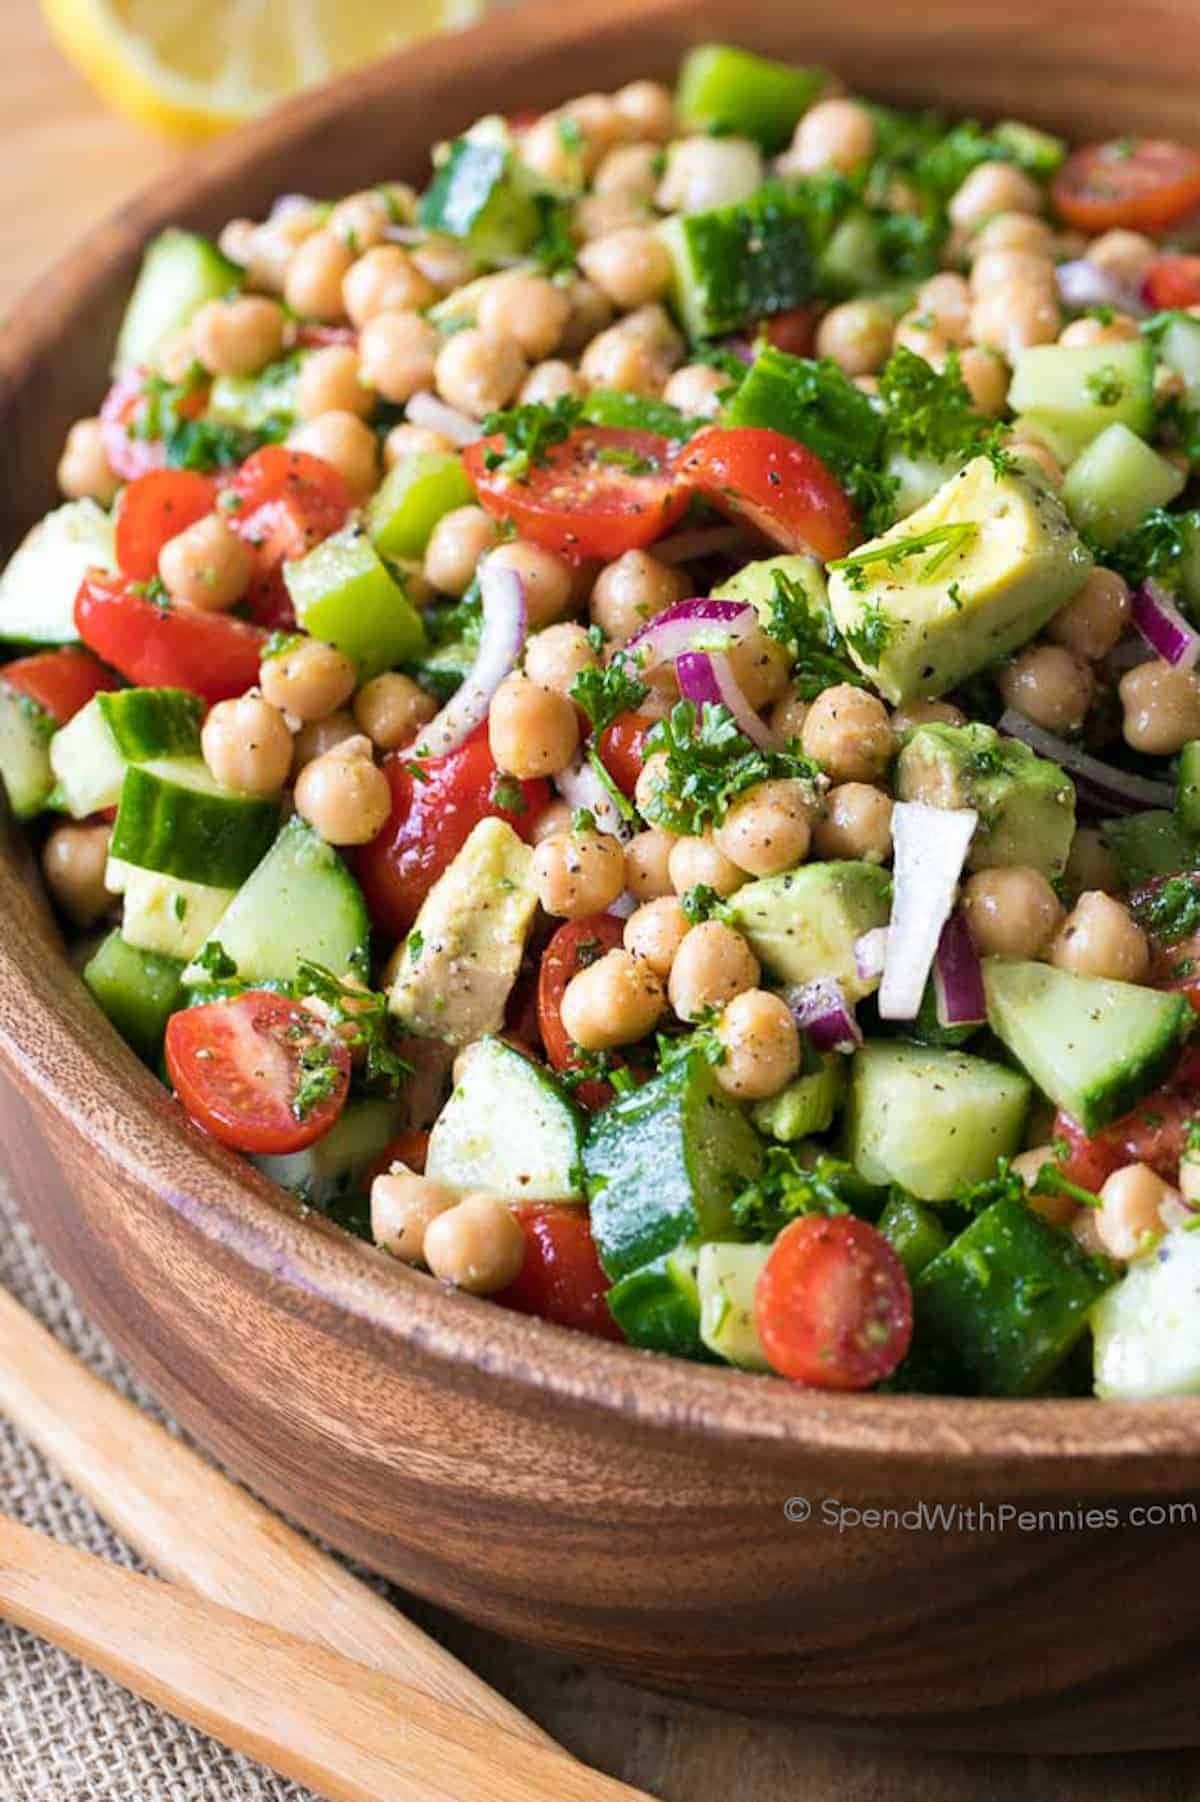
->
845;1040;1029;1202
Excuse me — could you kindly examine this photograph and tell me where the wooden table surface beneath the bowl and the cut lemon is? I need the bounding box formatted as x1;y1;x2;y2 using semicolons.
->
0;0;1200;1802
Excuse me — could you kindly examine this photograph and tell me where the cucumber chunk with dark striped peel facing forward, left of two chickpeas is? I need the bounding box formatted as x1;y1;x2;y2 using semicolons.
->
110;757;279;888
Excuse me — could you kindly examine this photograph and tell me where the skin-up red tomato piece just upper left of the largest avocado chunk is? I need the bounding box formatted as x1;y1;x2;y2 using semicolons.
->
679;425;858;562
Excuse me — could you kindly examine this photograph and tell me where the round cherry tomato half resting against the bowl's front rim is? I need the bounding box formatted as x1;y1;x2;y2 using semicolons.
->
755;1215;912;1389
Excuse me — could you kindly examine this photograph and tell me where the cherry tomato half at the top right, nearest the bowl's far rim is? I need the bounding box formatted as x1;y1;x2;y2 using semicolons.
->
1050;137;1200;232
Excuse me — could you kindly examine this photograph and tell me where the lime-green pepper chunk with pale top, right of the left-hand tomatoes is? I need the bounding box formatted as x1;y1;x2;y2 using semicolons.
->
283;524;425;681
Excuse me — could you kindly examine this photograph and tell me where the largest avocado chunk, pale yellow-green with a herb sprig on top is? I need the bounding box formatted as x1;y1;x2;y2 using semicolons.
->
829;456;1092;703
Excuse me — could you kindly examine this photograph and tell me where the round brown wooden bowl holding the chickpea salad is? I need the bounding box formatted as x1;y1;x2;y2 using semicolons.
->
0;0;1200;1752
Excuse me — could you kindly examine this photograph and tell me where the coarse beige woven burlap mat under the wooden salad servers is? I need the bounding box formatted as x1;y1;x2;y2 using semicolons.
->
0;1184;310;1802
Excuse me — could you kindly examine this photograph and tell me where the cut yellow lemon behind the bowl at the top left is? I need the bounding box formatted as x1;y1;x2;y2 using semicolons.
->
41;0;485;141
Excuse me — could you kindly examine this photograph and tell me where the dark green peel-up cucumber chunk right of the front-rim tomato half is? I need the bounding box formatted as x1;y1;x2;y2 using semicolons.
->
914;1200;1117;1395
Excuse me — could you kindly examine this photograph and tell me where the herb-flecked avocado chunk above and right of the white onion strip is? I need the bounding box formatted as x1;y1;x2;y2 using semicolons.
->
895;723;1076;878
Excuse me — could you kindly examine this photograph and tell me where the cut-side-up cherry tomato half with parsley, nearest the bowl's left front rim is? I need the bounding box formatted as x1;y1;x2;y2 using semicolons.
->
166;989;350;1155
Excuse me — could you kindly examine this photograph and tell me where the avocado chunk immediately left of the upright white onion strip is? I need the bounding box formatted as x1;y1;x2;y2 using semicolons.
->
726;863;892;1002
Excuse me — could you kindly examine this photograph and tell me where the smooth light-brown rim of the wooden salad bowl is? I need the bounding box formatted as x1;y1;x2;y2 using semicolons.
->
0;0;1200;1488
